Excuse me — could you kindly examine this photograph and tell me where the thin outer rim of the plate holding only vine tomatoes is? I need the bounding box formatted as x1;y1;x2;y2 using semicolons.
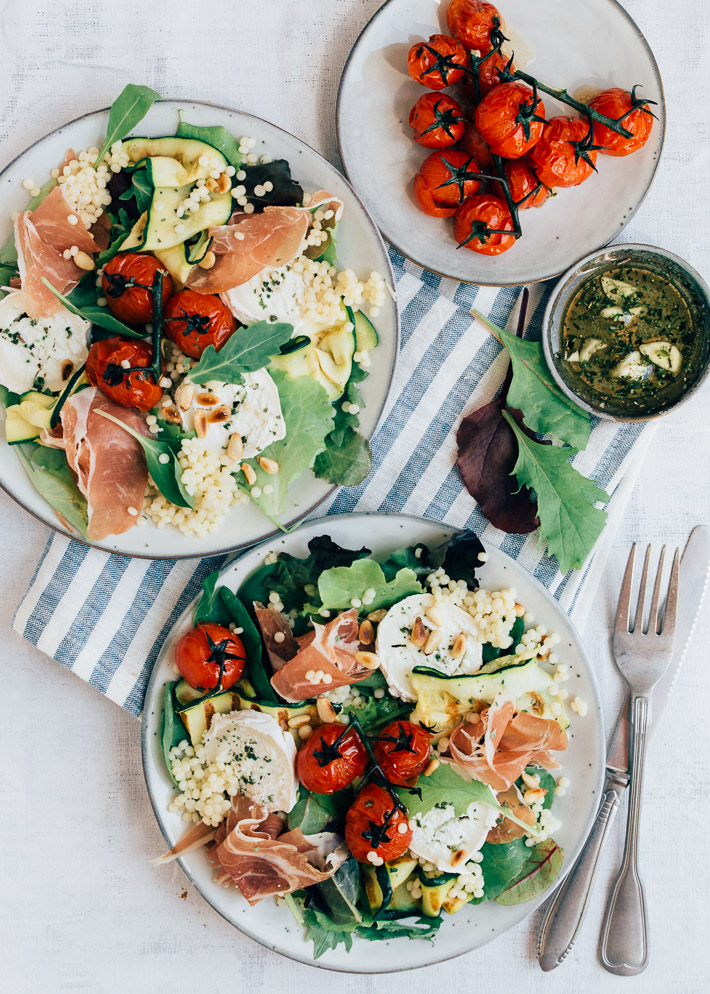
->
335;0;668;287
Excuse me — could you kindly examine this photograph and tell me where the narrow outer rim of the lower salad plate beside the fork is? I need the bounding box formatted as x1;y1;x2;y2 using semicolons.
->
140;511;606;976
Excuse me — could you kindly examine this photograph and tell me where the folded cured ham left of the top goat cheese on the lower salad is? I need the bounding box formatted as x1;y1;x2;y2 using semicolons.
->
271;608;372;703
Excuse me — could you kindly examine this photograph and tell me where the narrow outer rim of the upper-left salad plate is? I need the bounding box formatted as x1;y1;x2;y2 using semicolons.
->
0;97;401;561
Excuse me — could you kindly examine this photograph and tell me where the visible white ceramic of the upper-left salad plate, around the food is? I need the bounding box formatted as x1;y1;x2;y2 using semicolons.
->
0;100;399;559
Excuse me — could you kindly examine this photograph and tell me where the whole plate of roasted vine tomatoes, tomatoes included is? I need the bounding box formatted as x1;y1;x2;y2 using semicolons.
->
337;0;665;286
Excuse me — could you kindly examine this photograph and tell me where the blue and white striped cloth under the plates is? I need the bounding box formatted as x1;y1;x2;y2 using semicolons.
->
13;249;651;716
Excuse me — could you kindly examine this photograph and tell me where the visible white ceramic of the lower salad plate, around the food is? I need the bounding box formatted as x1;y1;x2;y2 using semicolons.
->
142;514;604;973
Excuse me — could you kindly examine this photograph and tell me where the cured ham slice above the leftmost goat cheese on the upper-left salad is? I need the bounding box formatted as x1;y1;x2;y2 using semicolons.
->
15;186;99;318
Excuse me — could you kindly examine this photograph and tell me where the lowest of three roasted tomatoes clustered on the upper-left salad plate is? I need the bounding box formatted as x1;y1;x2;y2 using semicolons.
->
86;336;163;411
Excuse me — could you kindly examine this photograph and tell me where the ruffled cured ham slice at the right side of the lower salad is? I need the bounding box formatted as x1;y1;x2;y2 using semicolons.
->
449;694;567;791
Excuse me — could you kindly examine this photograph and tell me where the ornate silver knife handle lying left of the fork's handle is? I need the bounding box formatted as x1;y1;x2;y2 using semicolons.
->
537;780;626;972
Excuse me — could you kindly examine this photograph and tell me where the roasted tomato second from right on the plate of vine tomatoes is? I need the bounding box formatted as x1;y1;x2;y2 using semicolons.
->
528;117;597;189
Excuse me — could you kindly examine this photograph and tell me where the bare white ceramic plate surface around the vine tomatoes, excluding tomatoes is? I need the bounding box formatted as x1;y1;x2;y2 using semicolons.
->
338;0;665;286
